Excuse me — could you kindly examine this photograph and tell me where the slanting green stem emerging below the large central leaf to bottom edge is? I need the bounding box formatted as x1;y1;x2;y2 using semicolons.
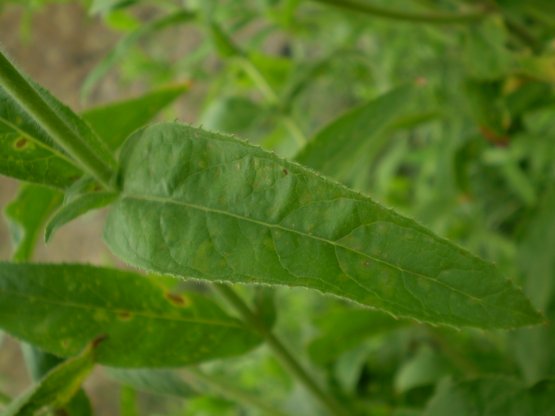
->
214;283;348;416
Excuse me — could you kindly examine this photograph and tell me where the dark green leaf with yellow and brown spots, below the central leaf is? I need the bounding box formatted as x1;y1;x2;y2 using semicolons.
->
0;263;259;367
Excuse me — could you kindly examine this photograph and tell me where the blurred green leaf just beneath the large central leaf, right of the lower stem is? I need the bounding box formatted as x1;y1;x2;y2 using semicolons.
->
308;308;407;364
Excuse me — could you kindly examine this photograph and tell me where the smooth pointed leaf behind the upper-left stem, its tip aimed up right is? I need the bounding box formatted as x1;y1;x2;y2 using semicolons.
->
82;84;189;150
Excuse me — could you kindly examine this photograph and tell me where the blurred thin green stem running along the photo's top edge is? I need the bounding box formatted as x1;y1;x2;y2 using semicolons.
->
313;0;490;24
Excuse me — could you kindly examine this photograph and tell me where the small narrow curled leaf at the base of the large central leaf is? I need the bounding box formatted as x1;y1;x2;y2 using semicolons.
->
44;192;117;242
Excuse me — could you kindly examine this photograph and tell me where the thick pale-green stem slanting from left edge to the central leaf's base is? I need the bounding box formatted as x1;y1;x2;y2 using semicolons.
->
0;51;115;189
